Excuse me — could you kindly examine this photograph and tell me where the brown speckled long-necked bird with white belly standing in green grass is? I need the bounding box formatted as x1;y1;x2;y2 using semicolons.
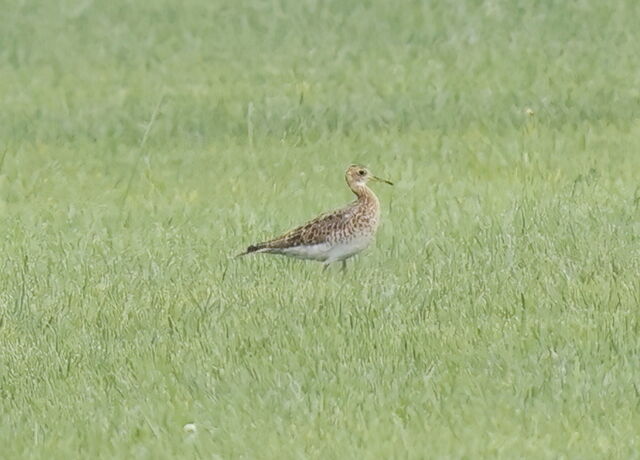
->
237;165;393;270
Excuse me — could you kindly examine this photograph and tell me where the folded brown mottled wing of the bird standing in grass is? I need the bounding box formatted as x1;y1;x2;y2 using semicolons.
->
259;206;353;249
